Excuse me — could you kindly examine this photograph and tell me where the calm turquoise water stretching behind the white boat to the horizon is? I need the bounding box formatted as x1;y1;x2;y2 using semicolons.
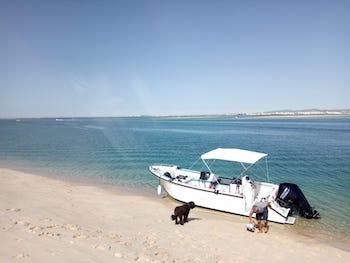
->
0;117;350;241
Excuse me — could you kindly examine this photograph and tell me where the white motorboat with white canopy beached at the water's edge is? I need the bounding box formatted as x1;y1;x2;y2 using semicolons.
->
149;148;319;224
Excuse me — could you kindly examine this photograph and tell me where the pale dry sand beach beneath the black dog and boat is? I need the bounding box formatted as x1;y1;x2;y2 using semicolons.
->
0;169;350;262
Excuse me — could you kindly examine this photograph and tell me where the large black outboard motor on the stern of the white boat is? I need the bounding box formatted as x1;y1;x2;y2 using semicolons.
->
276;183;320;219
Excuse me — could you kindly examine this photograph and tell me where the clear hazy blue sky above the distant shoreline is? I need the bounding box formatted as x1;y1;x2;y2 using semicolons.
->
0;0;350;117
